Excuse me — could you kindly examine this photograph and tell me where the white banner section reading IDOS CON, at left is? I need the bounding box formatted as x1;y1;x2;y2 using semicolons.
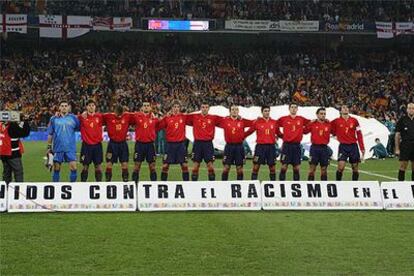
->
8;182;137;212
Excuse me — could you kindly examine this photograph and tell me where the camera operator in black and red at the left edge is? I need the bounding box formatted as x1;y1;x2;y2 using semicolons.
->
0;115;30;184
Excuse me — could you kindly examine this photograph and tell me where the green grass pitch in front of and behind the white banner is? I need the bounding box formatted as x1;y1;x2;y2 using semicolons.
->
0;142;414;275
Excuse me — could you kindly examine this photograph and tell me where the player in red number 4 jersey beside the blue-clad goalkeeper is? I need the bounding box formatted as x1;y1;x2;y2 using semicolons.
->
78;99;104;182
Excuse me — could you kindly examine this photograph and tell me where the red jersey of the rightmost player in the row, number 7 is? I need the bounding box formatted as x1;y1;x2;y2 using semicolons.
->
332;117;365;151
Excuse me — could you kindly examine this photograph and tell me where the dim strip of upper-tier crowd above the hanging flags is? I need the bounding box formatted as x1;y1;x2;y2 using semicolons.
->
1;0;414;22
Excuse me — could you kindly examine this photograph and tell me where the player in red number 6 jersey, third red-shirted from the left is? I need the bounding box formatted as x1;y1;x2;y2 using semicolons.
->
130;102;159;183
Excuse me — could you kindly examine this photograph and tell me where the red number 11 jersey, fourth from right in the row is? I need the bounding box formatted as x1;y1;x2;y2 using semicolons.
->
245;118;279;144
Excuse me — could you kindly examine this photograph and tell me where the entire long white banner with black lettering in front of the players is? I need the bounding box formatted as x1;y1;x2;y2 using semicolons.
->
0;181;414;213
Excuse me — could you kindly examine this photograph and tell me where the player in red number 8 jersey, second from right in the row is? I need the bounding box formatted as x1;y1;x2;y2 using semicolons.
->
305;107;332;181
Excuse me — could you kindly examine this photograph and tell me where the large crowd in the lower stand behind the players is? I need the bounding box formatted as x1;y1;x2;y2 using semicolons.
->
0;46;414;134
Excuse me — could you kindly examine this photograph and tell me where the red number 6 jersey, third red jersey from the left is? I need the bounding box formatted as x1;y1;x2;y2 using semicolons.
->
130;112;159;143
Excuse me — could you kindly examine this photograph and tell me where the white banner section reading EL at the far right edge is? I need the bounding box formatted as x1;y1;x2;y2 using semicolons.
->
381;181;414;210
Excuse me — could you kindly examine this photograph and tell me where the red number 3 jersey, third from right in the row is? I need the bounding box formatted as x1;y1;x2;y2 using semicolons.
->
277;115;310;143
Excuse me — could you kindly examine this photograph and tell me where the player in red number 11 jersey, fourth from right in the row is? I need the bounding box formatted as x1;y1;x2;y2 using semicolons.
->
245;105;279;181
